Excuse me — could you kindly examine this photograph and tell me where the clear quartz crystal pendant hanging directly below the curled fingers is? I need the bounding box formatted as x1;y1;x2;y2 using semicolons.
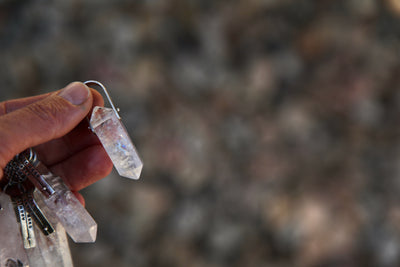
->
35;162;97;243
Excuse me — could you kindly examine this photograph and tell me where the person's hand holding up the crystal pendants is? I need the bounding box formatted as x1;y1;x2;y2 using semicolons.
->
0;82;112;203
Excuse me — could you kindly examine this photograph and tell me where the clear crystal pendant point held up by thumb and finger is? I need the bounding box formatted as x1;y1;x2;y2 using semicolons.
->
90;106;143;179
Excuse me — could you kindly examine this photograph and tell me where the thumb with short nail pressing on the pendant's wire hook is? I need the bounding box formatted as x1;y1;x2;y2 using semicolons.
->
0;82;93;172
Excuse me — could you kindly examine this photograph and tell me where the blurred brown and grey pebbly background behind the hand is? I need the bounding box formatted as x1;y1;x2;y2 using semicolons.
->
0;0;400;267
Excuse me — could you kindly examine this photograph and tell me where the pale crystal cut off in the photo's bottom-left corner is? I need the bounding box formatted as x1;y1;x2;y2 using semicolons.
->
0;192;29;267
